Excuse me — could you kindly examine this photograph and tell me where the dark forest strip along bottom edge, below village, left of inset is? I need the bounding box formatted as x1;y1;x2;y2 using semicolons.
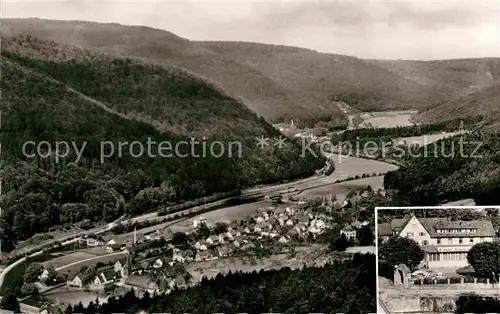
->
66;254;376;314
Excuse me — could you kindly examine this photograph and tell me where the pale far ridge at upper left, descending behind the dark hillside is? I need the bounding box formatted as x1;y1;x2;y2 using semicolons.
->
0;19;347;126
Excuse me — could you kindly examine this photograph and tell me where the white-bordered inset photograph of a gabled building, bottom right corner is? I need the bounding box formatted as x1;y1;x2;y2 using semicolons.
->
375;206;500;313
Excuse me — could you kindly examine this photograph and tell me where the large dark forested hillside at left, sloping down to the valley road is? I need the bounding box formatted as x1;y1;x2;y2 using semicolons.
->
0;36;324;250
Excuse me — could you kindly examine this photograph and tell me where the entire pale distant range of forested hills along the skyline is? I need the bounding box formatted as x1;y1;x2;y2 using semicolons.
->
0;19;500;129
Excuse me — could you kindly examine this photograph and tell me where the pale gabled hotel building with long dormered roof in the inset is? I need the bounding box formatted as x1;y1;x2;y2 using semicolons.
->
378;215;495;269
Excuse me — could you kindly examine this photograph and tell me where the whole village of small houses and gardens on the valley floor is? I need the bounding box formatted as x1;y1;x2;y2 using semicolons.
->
11;190;374;313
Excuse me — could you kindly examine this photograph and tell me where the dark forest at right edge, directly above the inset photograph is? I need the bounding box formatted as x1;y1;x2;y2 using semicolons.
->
384;132;500;206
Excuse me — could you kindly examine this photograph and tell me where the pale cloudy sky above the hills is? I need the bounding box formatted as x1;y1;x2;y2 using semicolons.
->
1;0;500;60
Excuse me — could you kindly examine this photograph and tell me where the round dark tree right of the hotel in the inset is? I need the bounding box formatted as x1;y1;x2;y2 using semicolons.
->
467;242;500;278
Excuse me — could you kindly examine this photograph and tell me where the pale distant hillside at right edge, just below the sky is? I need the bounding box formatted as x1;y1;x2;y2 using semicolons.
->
370;58;500;126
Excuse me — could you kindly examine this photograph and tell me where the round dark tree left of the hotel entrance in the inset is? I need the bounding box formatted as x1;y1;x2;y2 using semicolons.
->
379;237;424;270
